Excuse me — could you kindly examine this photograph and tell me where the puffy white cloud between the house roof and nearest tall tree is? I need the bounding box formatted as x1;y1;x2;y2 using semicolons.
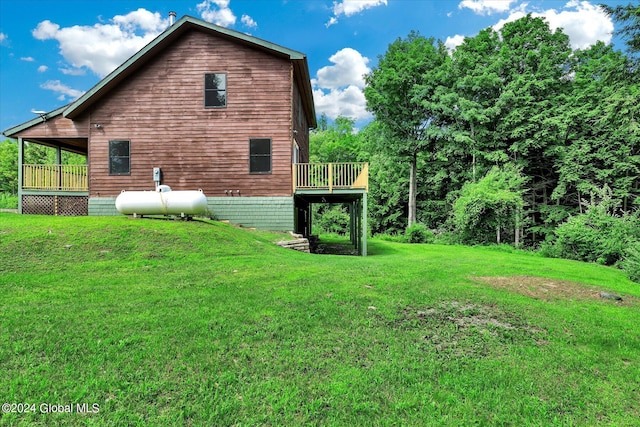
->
311;48;371;120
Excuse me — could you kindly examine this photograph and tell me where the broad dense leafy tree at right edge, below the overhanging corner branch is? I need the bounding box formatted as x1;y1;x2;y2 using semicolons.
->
552;42;640;213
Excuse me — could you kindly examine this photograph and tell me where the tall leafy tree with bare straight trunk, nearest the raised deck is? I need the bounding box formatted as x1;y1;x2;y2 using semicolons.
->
364;32;449;225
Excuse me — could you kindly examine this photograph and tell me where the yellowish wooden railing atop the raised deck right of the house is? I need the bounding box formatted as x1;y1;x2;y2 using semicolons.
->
293;163;369;193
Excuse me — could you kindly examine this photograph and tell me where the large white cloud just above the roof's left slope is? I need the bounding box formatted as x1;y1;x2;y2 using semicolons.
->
32;9;169;77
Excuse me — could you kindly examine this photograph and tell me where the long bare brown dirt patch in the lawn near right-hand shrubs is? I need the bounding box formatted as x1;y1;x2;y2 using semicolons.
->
471;276;637;305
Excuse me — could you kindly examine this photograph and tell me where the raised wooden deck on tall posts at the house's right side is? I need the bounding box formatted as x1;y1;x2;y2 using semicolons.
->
292;163;369;256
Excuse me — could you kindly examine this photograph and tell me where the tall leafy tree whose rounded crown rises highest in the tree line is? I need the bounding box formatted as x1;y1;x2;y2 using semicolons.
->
495;16;571;242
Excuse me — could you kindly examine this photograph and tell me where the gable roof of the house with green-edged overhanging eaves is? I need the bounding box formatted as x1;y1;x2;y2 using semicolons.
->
4;16;317;135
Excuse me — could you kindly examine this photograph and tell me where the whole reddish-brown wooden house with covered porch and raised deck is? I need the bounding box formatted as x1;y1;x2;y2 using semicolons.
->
4;16;368;253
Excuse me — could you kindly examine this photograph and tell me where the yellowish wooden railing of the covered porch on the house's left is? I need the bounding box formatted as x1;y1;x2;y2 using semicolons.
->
22;165;89;191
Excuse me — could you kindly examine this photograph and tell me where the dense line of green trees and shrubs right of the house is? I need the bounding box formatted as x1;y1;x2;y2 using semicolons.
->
311;10;640;251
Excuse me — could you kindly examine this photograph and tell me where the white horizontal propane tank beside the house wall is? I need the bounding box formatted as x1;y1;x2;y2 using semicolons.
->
116;185;207;216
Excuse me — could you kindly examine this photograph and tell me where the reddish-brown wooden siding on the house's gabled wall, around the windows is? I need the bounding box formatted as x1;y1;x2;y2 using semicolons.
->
82;31;298;196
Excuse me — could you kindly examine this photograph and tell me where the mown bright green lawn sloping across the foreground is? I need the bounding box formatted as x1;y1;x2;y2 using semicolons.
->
0;214;640;426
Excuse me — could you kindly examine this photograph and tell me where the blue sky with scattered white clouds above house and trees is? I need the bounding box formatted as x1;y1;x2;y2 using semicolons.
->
0;0;628;131
